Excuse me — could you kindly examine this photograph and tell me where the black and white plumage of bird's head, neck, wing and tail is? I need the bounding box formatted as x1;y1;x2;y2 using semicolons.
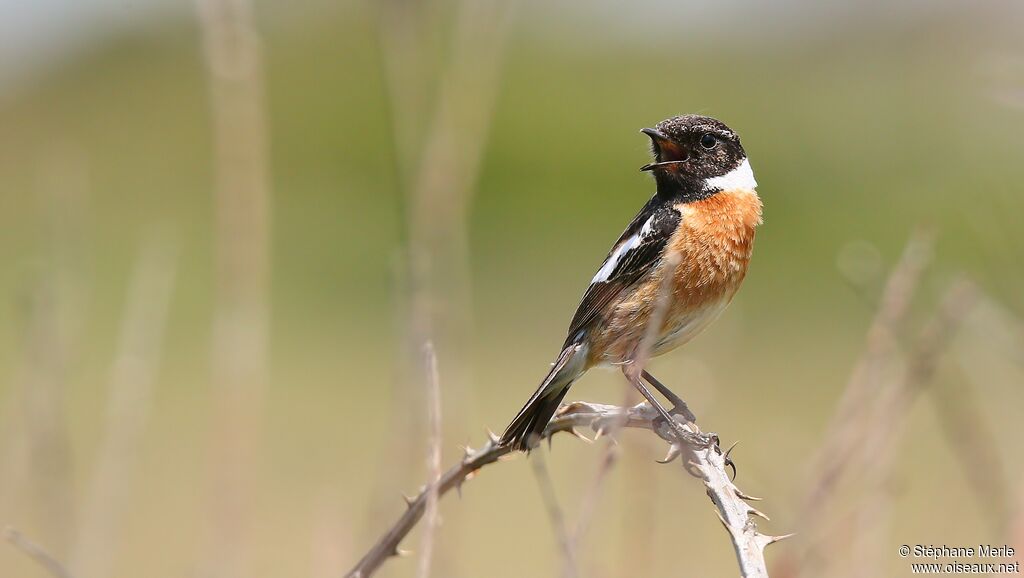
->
502;116;760;450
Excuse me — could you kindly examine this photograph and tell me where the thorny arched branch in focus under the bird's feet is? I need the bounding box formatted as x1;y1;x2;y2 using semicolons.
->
346;402;786;578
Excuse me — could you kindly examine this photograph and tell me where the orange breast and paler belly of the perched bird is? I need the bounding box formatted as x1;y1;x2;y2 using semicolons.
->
590;190;761;365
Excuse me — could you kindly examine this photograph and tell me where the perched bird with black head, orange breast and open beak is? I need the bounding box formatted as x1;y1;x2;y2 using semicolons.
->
501;115;761;450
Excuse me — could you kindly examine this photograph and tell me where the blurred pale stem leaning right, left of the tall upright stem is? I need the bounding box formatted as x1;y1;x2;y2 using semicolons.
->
71;239;175;578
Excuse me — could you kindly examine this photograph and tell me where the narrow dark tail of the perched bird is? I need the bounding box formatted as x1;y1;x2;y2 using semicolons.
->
499;343;587;451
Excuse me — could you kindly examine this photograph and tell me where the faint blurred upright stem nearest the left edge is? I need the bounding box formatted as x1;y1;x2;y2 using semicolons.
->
17;148;90;558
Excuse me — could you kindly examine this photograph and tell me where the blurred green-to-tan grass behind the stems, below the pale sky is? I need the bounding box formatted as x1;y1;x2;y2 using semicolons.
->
0;4;1024;576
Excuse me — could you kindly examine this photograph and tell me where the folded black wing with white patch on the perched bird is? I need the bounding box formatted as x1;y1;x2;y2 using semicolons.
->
565;195;682;344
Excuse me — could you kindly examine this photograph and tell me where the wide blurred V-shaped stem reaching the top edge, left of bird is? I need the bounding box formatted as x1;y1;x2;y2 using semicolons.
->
371;0;510;549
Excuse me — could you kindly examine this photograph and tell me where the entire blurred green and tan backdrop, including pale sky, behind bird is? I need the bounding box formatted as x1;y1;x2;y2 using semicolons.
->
0;0;1024;577
